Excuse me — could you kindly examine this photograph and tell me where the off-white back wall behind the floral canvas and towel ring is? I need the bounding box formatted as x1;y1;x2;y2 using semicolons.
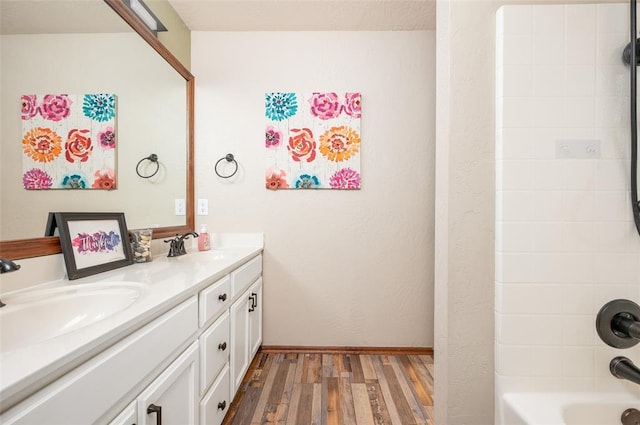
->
192;32;435;347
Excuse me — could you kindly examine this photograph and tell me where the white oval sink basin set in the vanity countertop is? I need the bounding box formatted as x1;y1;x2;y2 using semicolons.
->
0;282;146;352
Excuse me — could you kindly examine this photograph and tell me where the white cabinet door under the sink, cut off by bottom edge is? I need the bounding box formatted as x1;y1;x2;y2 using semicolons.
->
138;341;199;425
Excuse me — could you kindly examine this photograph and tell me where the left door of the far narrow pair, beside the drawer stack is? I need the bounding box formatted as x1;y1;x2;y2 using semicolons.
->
229;290;251;400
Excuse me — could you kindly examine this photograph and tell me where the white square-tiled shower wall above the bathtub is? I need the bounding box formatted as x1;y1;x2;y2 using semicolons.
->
496;4;640;392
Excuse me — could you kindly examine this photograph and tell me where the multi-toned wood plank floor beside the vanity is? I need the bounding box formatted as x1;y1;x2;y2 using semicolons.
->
223;352;433;425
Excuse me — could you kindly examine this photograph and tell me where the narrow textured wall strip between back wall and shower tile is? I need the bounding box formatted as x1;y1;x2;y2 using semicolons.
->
435;0;496;425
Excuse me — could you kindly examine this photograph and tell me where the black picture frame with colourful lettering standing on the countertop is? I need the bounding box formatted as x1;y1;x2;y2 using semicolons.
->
53;212;133;280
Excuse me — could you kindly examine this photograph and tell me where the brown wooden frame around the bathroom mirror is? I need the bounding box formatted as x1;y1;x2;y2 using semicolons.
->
0;0;195;260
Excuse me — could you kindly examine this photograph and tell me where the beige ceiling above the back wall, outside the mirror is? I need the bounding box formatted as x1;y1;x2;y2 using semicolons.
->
165;0;436;31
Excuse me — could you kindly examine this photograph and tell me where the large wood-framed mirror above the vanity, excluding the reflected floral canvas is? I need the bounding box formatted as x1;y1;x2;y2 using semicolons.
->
0;0;194;259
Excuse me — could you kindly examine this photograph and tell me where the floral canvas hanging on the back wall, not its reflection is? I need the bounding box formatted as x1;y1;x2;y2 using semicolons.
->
265;92;362;190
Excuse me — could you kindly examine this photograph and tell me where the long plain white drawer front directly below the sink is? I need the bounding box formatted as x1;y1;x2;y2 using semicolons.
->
0;296;198;425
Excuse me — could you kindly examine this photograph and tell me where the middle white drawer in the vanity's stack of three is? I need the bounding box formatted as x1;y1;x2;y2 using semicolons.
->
200;311;231;394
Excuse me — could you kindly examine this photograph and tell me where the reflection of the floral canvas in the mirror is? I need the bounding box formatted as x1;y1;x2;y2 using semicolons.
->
21;93;116;190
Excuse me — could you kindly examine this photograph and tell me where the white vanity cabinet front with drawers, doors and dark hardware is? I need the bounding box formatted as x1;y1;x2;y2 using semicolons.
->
0;255;262;425
